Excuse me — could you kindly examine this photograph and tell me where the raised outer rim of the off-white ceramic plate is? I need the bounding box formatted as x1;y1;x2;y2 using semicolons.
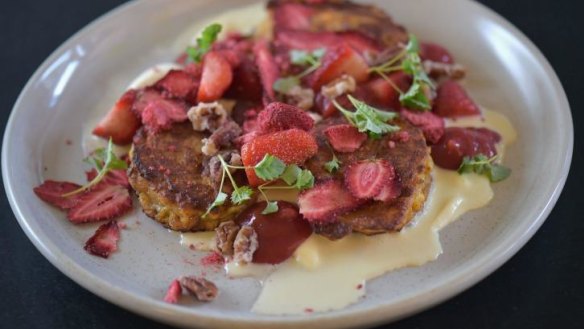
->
2;0;573;328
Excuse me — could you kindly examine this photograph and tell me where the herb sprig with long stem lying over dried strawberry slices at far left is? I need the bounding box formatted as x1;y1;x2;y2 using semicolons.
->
62;138;128;197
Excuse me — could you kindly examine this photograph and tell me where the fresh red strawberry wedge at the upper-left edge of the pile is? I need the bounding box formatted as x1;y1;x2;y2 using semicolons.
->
93;90;140;145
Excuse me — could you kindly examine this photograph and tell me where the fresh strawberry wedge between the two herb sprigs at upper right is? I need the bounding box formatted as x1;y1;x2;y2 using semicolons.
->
310;45;369;91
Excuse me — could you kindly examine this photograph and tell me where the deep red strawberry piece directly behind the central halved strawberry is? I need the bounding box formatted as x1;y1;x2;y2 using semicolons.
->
257;102;314;134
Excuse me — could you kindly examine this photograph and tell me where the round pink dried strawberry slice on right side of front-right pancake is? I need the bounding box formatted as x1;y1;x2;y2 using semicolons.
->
345;160;396;200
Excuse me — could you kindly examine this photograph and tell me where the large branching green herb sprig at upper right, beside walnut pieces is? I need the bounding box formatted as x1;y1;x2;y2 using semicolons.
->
369;34;436;111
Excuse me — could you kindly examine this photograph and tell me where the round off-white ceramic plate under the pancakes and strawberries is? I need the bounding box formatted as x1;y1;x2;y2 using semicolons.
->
2;0;573;328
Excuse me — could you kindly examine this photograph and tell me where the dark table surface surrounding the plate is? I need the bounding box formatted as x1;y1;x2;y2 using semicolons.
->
0;0;584;329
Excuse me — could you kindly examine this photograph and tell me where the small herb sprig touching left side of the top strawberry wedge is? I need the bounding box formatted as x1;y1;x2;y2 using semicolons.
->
273;48;326;94
